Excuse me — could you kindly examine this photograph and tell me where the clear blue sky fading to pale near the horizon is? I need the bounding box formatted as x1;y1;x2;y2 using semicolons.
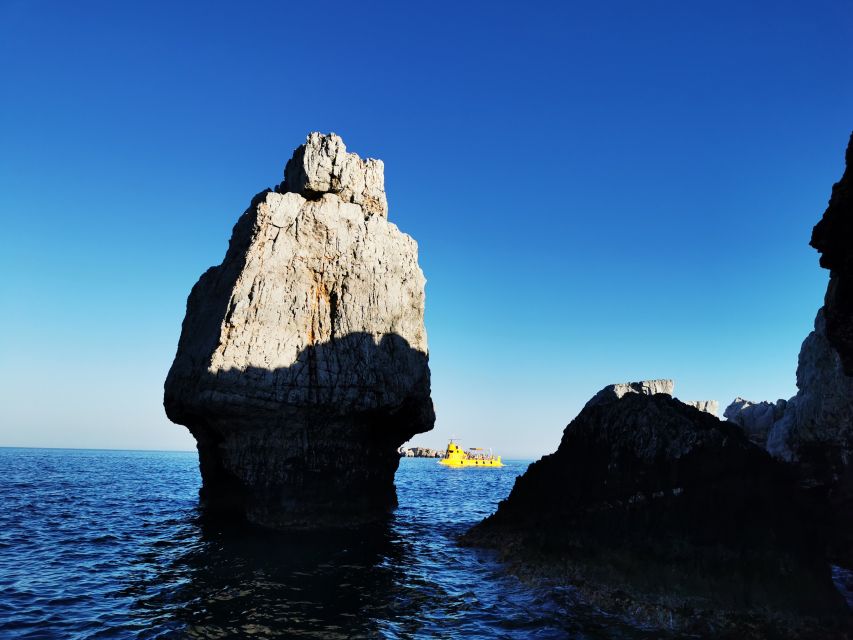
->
0;0;853;457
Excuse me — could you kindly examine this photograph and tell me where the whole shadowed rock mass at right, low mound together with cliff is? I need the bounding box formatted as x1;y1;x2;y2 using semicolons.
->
461;136;853;638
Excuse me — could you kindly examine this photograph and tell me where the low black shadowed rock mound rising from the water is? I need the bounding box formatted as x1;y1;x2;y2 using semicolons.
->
463;384;846;635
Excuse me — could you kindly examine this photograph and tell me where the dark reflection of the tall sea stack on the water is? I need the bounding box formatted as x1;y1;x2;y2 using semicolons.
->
143;522;410;638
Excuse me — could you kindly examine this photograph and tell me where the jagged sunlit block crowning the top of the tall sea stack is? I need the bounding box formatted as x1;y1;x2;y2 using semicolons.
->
279;131;388;217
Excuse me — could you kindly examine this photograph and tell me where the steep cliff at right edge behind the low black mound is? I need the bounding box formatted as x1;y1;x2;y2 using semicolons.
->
725;136;853;568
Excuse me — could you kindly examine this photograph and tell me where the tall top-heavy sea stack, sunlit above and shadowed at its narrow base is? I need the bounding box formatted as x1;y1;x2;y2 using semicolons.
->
164;133;435;528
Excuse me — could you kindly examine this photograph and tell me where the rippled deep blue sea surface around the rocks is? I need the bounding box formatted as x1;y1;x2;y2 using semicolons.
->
0;448;684;640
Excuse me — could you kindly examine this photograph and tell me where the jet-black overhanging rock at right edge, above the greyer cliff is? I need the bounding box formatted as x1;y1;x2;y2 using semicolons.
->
811;135;853;376
